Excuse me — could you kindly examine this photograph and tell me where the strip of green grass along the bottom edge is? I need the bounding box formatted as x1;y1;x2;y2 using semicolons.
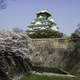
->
20;74;76;80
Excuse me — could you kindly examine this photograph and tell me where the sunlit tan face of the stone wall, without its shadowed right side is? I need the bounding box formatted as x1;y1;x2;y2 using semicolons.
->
32;38;72;67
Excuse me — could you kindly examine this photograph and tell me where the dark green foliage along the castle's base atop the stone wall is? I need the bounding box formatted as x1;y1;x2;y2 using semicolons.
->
28;29;63;38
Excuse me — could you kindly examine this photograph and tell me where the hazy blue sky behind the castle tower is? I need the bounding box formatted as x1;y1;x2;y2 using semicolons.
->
0;0;80;34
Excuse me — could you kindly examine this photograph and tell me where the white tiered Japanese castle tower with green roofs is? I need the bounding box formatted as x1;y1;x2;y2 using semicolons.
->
27;10;59;33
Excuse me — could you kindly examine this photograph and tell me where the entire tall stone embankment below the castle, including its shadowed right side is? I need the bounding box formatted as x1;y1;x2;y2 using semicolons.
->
32;38;80;76
